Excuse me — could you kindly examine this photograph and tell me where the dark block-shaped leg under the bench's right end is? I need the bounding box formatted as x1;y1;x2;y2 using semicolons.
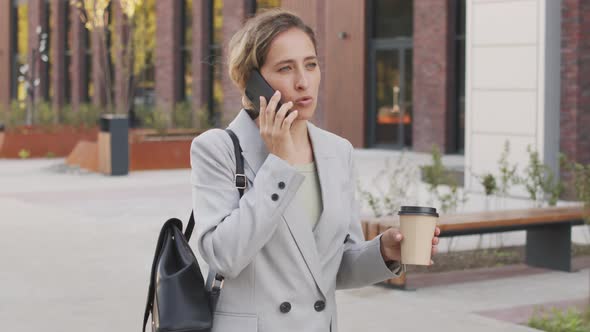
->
526;224;572;272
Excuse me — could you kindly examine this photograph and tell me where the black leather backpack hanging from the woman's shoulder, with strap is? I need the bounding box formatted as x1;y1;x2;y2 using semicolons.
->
143;129;247;332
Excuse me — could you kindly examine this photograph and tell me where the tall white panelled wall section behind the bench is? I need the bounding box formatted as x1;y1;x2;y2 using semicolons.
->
465;0;561;196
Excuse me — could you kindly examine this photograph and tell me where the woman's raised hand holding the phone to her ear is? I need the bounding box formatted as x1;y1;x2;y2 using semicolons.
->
260;90;298;165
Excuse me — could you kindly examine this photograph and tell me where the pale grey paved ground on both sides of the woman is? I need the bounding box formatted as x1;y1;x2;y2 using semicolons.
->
0;159;590;332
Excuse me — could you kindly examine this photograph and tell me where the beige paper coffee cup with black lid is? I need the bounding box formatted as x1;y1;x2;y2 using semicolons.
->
399;206;438;265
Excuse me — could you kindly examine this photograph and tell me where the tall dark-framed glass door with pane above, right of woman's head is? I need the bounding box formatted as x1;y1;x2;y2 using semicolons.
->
368;0;414;149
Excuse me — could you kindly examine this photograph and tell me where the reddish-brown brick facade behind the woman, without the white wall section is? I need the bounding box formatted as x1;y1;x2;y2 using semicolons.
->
0;0;590;162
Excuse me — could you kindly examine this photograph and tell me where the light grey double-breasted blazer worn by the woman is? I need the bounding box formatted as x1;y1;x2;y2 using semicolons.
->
191;110;399;332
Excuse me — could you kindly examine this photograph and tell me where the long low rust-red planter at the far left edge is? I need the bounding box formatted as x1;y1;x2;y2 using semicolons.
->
0;126;98;158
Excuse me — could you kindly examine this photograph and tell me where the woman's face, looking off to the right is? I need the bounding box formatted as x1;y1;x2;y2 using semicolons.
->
260;28;321;120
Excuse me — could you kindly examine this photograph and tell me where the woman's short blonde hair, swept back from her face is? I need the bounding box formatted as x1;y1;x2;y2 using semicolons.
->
228;8;317;116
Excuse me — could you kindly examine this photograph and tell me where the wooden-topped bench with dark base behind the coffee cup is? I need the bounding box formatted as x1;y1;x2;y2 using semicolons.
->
362;206;588;285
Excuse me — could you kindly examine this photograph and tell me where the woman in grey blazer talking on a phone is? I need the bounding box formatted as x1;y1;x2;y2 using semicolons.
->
191;10;439;332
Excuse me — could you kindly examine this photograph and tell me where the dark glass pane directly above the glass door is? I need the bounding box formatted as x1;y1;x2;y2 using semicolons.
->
373;0;414;38
